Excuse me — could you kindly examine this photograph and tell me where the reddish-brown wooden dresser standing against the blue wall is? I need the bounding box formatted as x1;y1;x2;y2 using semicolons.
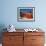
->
2;32;44;46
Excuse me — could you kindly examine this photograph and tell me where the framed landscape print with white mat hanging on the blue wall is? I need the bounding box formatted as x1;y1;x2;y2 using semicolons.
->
17;7;35;22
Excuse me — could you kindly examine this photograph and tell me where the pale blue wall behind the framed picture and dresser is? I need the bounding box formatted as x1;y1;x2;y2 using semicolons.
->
0;0;46;28
